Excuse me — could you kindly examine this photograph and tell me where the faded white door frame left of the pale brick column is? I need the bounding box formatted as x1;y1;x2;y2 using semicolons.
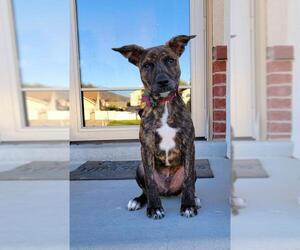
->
229;0;257;138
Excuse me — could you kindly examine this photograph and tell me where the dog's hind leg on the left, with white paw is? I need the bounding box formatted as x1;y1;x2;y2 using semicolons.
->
127;164;147;211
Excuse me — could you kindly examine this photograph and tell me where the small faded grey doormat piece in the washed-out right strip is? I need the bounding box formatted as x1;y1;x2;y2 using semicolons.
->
233;159;269;178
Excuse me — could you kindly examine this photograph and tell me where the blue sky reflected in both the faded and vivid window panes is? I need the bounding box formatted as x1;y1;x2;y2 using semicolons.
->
13;0;190;88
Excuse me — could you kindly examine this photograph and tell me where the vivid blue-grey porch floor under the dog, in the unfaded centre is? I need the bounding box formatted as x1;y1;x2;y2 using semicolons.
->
70;158;230;250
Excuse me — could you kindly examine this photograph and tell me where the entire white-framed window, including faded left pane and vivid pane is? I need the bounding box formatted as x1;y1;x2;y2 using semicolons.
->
0;0;207;141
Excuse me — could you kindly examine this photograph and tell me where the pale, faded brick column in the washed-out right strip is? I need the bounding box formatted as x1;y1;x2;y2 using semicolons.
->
267;46;293;140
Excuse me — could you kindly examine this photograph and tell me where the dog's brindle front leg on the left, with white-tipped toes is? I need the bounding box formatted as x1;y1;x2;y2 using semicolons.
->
142;145;165;219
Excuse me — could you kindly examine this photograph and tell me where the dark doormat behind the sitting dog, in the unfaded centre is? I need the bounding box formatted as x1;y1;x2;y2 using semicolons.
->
70;159;214;181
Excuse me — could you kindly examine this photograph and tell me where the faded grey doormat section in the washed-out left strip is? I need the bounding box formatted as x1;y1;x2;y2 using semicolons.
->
0;161;70;181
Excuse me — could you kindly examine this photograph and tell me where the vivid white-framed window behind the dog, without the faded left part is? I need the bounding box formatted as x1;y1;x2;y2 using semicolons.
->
71;0;206;140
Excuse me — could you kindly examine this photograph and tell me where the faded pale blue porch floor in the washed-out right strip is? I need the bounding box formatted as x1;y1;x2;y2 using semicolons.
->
231;158;300;250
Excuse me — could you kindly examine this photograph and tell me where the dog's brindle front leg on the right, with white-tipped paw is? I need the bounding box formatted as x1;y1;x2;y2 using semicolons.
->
180;143;198;217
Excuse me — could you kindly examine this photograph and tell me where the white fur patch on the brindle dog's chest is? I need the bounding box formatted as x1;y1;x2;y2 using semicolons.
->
157;103;178;166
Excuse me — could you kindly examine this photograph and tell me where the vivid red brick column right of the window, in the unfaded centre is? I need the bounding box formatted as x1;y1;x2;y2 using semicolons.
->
212;46;227;140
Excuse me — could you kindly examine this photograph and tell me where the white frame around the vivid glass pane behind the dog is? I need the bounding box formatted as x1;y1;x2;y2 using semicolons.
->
70;0;208;141
